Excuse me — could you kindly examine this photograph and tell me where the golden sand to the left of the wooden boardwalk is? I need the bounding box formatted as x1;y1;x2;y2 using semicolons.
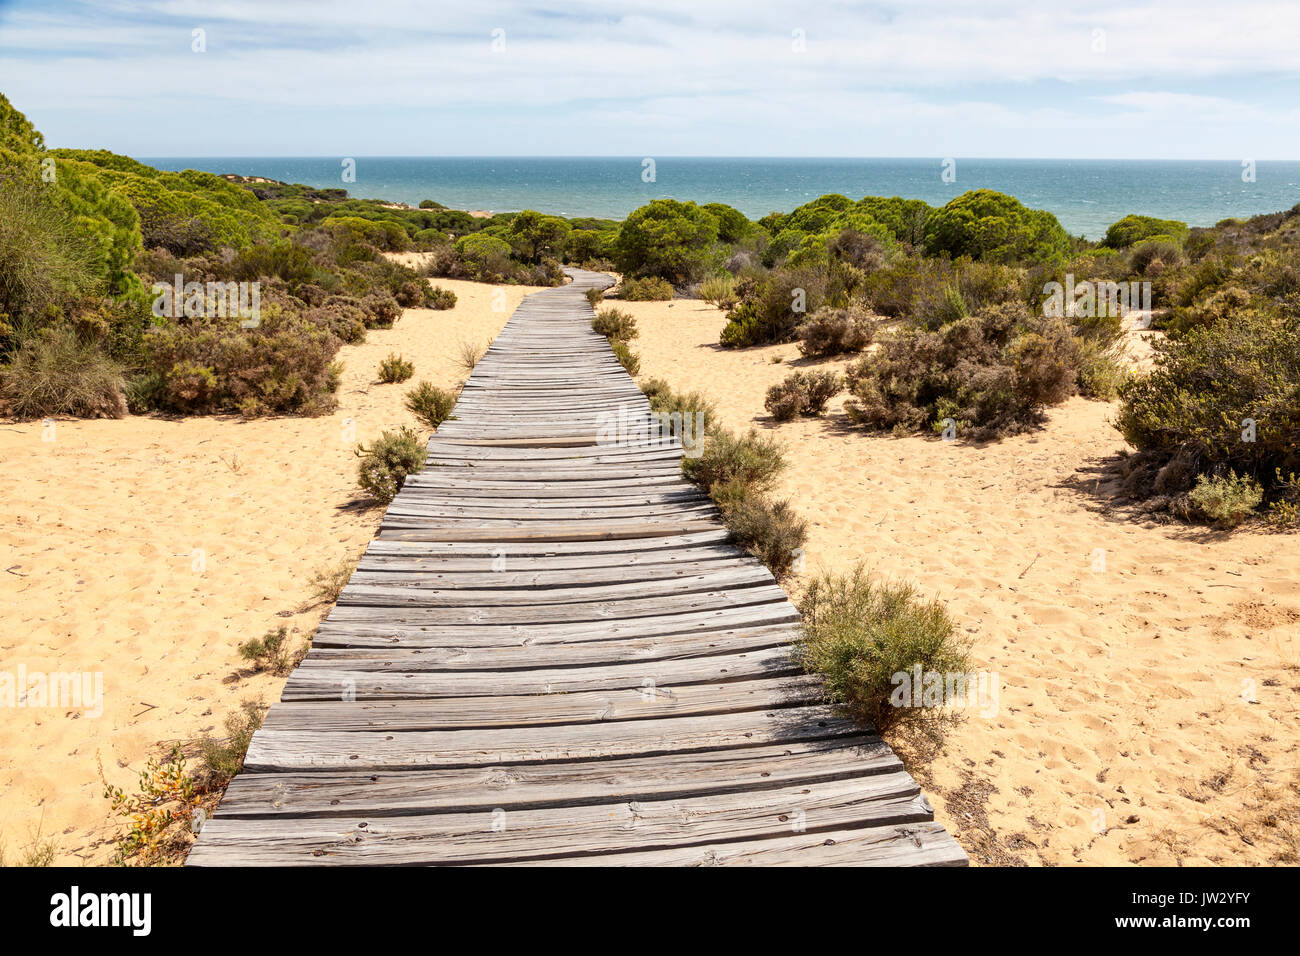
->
0;280;532;865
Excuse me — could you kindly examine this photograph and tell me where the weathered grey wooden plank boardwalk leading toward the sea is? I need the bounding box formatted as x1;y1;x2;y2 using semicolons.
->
189;271;966;865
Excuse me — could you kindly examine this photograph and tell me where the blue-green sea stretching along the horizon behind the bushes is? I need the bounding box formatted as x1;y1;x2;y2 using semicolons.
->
142;156;1300;239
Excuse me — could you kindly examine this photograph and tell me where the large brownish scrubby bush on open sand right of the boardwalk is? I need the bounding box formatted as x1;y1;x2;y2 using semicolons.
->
844;306;1079;440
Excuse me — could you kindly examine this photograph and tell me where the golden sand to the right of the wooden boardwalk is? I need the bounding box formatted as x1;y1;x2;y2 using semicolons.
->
619;299;1300;865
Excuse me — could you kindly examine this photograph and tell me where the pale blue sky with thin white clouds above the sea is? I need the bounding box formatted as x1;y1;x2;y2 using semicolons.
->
0;0;1300;160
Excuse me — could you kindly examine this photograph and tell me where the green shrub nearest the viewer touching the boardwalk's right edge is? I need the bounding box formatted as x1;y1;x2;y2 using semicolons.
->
798;567;970;732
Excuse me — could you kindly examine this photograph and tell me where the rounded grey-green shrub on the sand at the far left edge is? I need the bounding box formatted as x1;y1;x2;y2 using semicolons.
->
0;325;126;419
